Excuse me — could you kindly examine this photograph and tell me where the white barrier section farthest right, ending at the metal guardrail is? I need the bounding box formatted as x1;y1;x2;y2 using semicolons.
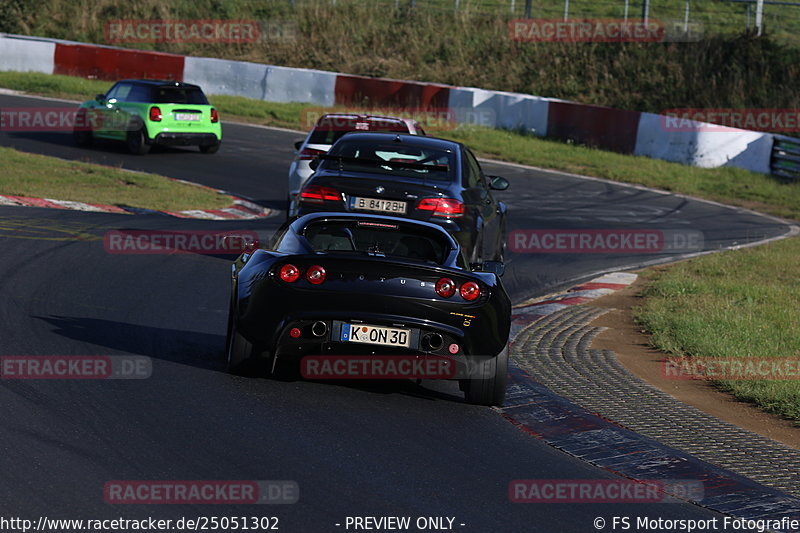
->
634;113;772;174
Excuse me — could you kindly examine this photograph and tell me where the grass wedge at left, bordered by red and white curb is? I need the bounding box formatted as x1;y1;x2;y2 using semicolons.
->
0;147;230;211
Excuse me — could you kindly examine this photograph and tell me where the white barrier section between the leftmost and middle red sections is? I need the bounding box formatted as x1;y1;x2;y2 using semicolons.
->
183;56;336;106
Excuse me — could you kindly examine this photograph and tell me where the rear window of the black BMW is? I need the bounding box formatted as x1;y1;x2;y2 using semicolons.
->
322;139;455;181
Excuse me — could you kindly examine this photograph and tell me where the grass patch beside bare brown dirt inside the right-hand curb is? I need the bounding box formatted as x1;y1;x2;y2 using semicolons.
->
634;237;800;425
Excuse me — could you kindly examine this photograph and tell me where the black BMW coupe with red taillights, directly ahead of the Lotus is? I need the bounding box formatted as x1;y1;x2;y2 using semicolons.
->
299;133;508;262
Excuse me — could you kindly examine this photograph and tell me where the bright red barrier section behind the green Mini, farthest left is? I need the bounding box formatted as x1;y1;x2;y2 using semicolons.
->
53;43;183;81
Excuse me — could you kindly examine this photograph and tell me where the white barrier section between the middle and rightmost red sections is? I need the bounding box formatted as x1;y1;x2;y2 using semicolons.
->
449;87;549;137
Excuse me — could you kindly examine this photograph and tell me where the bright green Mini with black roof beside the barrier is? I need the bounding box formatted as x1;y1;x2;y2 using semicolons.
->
73;80;222;155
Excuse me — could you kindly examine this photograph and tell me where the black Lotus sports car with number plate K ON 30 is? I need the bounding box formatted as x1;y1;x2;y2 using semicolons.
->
227;213;511;405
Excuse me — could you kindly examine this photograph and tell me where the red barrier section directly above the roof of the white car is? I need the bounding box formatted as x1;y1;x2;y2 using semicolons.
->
335;74;450;109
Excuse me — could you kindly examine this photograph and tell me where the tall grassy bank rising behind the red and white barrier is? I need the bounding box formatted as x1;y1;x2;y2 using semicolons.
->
0;0;800;112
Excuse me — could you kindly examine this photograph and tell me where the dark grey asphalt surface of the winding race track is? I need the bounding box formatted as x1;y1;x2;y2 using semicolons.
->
0;96;788;532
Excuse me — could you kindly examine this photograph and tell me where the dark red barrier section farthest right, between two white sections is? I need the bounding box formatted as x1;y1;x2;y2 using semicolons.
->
547;102;639;154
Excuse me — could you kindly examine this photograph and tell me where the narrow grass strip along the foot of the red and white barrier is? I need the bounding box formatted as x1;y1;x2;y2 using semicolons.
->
0;72;800;220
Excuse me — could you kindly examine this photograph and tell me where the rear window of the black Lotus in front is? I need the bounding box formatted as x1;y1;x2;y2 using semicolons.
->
303;221;450;265
